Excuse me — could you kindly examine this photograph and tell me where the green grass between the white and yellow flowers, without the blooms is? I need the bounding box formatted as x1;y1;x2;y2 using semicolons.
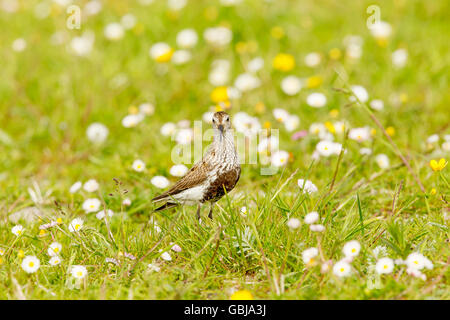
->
0;0;450;299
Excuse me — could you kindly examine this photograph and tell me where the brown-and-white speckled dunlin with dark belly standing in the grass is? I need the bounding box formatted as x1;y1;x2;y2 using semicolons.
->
152;111;241;220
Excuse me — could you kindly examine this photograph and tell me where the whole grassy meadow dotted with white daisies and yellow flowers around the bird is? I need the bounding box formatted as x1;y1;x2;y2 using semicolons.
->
0;0;450;299
